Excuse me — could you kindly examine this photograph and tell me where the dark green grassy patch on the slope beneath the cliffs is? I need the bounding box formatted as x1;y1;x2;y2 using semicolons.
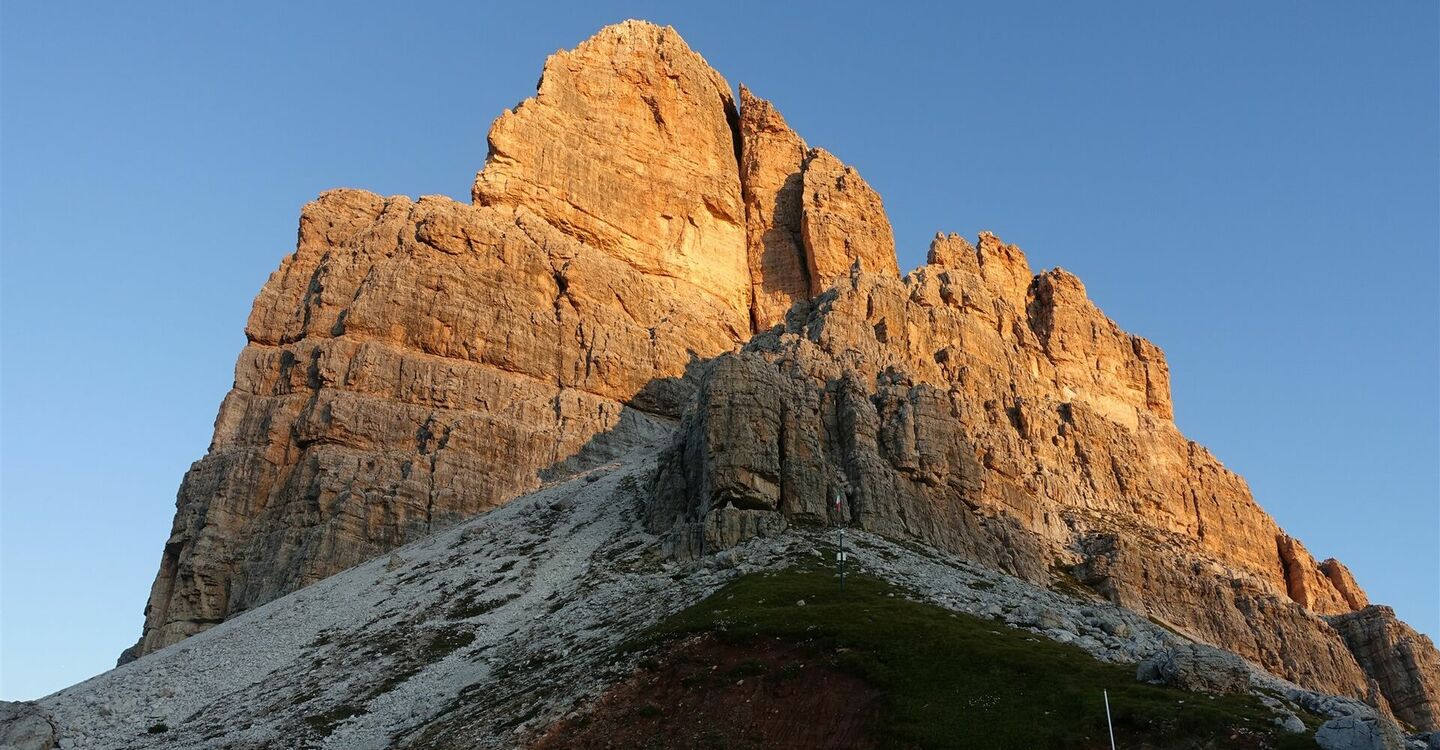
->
642;563;1315;750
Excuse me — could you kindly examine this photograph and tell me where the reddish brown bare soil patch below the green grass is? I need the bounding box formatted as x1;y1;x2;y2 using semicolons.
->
534;635;880;750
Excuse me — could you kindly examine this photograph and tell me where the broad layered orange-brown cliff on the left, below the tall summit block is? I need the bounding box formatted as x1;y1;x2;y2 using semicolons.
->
129;191;708;652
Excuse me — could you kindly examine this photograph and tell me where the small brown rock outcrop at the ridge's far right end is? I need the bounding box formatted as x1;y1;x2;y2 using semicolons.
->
1329;606;1440;728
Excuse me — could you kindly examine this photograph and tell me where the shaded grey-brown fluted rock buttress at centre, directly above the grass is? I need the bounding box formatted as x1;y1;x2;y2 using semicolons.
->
651;353;1045;580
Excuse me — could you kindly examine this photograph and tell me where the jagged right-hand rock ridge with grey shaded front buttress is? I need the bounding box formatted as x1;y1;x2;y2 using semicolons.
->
651;235;1440;711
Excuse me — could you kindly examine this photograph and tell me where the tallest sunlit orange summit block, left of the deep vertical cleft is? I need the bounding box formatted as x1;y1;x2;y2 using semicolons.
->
474;22;750;322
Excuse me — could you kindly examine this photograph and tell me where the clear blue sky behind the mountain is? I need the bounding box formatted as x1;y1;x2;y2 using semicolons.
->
0;0;1440;698
